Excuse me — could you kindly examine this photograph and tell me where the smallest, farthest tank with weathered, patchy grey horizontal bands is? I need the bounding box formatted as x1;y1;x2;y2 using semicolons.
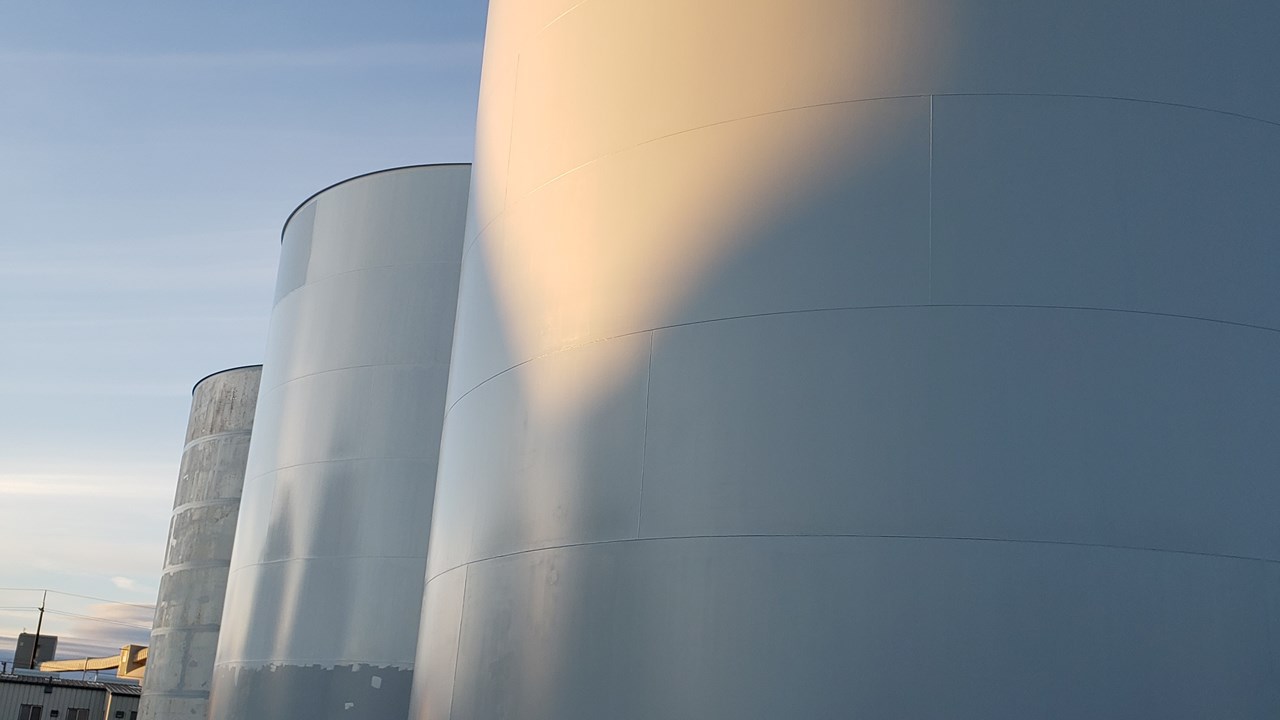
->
138;365;262;720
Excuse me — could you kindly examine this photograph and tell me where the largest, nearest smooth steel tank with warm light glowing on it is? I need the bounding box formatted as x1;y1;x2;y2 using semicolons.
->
411;0;1280;720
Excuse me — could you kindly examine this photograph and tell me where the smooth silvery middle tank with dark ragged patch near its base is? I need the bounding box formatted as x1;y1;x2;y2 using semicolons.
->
210;165;471;720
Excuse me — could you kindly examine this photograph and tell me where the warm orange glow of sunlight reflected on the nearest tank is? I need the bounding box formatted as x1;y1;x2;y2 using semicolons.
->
472;0;952;418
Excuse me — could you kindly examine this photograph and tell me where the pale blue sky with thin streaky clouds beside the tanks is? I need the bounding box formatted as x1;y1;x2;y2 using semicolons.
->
0;0;486;660
